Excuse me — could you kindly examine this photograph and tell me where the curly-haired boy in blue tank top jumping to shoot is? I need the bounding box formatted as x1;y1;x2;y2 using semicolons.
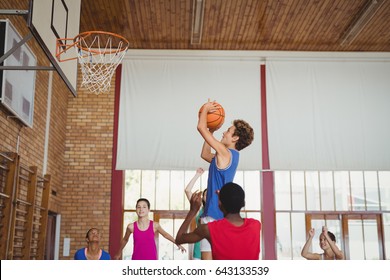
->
197;102;254;260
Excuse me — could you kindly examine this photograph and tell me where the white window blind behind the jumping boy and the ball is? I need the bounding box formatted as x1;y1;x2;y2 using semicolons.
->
116;52;261;170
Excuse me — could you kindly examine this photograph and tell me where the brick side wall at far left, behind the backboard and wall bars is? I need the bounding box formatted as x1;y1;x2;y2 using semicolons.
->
0;0;69;213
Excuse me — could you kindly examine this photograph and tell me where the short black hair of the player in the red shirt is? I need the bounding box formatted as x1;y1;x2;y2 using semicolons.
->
219;183;245;214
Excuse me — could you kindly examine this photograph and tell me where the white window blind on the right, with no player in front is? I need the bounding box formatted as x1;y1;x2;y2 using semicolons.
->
266;59;390;170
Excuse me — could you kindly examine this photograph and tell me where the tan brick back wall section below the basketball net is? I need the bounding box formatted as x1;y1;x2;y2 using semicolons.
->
60;75;115;259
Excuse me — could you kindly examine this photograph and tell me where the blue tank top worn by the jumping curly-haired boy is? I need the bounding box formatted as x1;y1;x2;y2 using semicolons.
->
203;149;240;220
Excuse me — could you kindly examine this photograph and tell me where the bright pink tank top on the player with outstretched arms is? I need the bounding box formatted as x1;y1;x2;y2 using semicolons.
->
131;221;157;260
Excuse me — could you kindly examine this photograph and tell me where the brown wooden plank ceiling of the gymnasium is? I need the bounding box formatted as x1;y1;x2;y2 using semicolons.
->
80;0;390;52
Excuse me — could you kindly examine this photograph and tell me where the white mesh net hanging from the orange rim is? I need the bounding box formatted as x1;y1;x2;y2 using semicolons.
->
75;34;128;94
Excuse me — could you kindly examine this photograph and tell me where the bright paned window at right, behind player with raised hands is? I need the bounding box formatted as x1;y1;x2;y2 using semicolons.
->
274;171;390;259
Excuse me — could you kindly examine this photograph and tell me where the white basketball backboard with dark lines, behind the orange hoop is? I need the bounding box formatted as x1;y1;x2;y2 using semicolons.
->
28;0;81;96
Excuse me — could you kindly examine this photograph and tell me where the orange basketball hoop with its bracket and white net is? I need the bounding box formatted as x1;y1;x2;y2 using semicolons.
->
56;31;129;94
